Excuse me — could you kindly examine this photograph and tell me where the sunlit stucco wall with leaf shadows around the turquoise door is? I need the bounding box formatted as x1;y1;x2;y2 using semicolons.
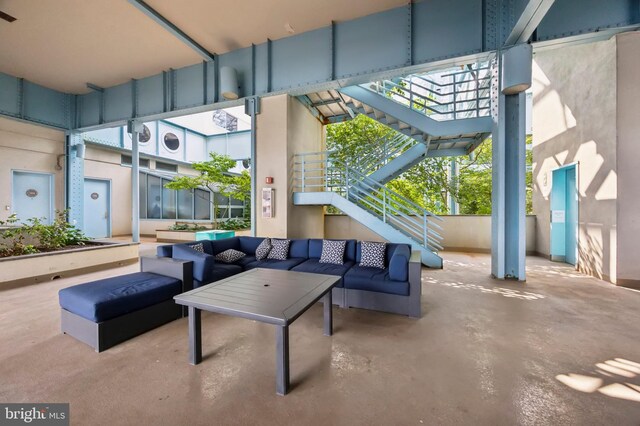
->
532;38;617;280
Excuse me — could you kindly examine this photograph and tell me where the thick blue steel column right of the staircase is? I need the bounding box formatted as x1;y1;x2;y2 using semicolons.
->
491;44;532;281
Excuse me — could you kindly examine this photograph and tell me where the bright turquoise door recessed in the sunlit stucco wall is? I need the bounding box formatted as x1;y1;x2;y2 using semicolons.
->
550;168;567;260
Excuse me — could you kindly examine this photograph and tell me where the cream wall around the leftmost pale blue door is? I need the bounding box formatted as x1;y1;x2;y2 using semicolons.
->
0;117;65;220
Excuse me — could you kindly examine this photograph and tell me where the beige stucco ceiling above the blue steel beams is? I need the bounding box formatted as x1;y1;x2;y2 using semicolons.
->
0;0;407;93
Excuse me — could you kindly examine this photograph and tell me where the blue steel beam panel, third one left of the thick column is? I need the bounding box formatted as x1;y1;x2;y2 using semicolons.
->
271;27;332;91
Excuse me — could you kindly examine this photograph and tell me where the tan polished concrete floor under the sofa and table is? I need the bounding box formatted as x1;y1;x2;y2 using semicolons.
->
0;246;640;426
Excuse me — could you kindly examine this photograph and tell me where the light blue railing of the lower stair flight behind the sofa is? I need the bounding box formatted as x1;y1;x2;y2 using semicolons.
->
293;152;442;252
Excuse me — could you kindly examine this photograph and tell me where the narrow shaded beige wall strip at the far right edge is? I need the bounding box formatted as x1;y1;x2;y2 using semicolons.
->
616;32;640;288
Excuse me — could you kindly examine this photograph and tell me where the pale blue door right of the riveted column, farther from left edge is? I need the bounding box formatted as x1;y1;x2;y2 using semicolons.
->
83;179;111;238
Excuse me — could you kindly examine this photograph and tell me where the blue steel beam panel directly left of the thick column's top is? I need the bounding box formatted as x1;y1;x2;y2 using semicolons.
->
413;0;483;63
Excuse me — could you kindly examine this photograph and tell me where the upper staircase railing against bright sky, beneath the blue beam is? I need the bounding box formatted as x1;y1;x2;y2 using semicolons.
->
361;63;491;121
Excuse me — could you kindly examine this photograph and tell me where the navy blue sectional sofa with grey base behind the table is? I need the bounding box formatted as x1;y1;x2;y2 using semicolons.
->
157;237;422;318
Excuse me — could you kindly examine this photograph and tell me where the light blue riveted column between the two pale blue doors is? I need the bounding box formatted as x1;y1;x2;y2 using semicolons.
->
65;132;84;229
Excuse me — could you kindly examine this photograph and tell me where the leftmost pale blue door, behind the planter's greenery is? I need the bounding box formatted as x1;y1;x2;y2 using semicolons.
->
12;171;53;224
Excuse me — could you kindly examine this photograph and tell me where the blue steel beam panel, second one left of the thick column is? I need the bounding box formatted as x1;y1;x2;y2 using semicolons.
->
332;7;411;79
